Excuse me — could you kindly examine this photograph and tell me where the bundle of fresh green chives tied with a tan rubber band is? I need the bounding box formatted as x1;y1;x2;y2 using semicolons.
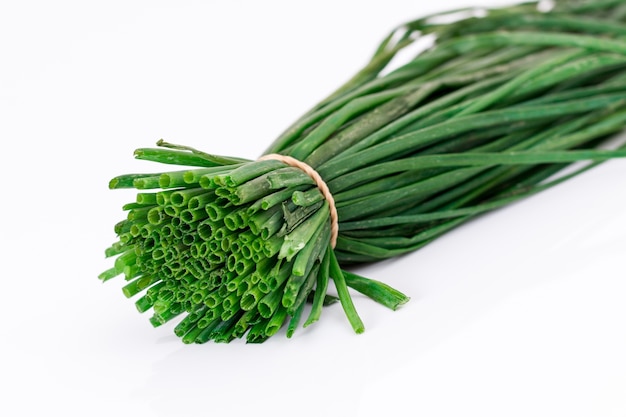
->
100;0;626;343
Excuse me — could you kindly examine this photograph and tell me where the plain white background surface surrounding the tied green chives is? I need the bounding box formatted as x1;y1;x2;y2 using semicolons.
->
0;0;626;417
